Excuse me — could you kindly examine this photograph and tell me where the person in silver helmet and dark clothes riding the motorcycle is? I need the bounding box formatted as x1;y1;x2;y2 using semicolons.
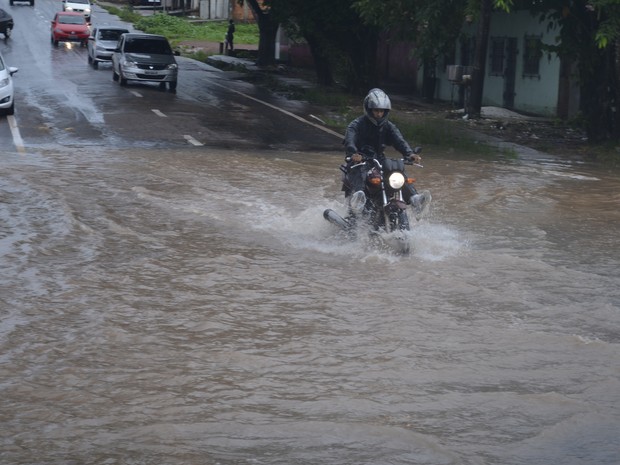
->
342;88;426;213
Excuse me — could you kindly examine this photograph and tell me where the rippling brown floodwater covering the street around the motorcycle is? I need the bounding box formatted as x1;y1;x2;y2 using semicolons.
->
0;143;620;465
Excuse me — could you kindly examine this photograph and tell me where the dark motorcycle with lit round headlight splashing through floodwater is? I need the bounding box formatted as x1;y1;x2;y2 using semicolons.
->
323;147;430;254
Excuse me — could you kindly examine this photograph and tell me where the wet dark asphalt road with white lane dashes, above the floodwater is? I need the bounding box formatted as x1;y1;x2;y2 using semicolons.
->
0;0;339;153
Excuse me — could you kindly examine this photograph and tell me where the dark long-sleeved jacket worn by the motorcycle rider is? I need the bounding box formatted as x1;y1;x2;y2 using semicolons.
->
343;116;413;157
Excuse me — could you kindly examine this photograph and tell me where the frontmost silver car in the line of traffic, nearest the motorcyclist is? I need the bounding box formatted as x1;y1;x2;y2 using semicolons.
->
112;33;178;91
